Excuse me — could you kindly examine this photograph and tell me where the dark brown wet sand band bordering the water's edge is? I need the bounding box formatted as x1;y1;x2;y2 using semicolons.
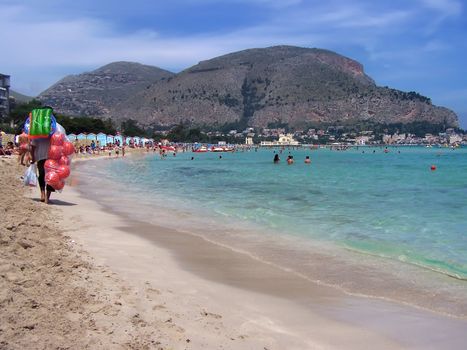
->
61;158;465;348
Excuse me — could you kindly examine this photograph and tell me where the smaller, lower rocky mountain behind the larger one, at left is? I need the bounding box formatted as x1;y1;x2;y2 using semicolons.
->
38;62;174;117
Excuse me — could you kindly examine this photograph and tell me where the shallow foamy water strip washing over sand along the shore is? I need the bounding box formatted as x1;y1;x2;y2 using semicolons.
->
71;150;467;319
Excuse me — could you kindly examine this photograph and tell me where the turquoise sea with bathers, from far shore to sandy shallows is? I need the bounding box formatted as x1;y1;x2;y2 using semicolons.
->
77;147;467;316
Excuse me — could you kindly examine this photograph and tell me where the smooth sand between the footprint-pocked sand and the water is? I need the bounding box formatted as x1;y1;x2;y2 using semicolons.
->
65;159;467;349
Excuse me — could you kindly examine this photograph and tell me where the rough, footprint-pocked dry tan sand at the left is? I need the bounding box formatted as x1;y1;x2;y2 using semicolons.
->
0;158;192;349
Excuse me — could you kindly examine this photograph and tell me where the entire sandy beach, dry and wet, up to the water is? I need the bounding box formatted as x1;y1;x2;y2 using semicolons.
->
0;159;467;349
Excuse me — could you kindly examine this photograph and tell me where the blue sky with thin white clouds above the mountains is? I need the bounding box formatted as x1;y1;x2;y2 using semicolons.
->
0;0;467;128
